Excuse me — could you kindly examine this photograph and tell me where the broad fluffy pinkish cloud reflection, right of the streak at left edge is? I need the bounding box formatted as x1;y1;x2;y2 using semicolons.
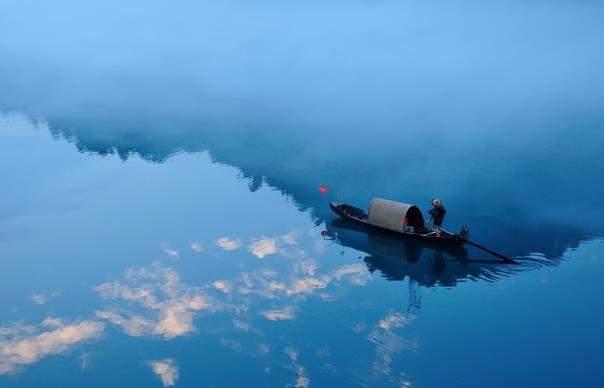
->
96;263;212;338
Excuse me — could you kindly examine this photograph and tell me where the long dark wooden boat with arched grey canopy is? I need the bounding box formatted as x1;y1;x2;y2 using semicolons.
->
329;198;468;245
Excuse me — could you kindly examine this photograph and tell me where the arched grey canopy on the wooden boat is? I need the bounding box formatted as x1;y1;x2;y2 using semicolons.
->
367;198;425;233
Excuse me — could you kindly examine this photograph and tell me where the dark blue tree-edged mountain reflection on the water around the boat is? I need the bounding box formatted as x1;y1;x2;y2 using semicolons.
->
3;109;602;286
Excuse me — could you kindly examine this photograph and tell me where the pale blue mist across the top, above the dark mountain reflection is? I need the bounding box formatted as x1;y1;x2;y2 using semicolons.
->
0;1;604;118
